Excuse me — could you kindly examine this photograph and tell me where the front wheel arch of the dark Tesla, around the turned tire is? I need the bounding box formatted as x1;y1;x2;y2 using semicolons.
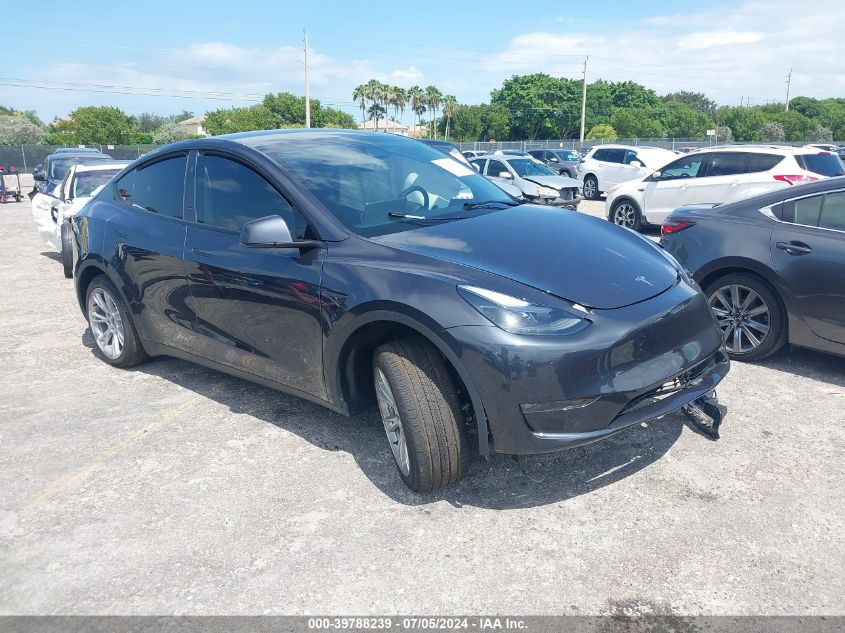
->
323;306;490;457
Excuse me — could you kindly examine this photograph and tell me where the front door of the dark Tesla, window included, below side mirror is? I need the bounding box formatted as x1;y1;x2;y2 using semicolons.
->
185;153;326;398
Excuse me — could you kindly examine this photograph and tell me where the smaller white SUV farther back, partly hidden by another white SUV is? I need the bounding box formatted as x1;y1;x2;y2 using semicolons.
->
578;145;678;200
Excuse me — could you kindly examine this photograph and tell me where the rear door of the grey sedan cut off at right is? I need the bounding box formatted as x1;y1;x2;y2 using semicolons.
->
771;191;845;343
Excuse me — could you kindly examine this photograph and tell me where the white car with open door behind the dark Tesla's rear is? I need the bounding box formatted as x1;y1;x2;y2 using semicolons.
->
32;161;129;277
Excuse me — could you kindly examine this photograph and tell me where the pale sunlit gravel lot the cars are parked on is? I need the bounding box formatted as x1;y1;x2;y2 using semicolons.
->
0;198;845;614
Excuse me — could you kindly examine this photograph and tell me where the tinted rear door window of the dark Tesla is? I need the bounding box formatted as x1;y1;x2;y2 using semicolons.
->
115;154;188;219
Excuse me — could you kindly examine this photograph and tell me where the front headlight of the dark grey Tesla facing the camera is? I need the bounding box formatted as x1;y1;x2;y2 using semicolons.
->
458;286;590;334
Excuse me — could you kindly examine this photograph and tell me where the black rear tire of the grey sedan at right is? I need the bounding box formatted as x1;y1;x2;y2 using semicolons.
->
704;273;788;362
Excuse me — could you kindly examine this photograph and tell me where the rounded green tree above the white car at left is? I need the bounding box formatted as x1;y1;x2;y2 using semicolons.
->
47;106;139;145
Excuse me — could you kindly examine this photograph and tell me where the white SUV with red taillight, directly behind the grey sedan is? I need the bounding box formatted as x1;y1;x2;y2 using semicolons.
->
605;145;845;231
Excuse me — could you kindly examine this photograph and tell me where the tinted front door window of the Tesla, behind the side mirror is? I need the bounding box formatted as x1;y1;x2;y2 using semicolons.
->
197;156;306;239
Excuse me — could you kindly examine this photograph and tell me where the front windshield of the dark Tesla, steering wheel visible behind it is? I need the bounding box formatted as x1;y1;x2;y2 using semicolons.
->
254;134;515;237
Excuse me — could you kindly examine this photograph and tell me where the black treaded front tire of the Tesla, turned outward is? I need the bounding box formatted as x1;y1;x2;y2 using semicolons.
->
373;337;470;492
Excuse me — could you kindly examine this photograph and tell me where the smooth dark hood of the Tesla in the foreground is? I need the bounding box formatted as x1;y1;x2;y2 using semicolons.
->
373;205;678;309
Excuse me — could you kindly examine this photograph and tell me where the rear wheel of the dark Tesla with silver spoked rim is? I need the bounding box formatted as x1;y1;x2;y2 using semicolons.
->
85;275;147;367
